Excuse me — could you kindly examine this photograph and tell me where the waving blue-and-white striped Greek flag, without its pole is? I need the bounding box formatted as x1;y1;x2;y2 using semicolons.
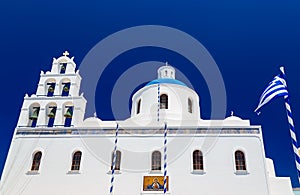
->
254;67;289;114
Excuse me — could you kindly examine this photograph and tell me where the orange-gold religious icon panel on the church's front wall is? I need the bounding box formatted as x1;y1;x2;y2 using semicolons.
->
143;176;169;191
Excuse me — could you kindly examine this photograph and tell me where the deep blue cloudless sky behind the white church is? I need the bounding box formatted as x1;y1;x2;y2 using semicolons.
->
0;0;300;186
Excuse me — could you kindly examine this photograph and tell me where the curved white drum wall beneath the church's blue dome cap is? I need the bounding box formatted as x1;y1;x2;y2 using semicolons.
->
131;84;200;120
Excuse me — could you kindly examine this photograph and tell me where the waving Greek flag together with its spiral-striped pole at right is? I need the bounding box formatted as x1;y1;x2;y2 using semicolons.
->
255;67;300;183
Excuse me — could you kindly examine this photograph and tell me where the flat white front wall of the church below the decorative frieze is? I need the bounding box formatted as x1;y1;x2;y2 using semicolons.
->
1;135;274;195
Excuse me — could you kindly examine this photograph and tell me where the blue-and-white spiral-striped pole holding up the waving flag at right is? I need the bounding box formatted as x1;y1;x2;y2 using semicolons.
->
280;67;300;184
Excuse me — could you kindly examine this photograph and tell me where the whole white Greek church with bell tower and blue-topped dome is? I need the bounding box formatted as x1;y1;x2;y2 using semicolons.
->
0;52;293;195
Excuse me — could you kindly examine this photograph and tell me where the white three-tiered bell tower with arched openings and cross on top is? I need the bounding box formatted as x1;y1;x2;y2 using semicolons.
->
17;51;86;128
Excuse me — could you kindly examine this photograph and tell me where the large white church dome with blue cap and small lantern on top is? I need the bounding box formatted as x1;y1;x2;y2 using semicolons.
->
131;64;200;121
